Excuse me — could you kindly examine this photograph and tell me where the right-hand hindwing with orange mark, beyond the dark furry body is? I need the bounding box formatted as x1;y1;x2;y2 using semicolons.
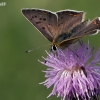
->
71;18;100;38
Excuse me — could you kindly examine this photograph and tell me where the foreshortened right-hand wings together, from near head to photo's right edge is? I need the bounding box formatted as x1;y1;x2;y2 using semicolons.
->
58;18;100;48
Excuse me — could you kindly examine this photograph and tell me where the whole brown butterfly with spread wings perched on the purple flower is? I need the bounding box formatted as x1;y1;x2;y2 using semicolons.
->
22;8;100;50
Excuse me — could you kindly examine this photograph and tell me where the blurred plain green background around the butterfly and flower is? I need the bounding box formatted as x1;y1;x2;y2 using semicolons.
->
0;0;100;100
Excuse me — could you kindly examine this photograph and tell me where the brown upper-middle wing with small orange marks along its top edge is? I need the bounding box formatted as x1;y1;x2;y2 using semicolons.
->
56;10;84;34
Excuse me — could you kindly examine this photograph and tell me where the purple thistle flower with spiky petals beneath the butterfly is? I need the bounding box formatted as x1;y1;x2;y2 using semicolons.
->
40;42;100;100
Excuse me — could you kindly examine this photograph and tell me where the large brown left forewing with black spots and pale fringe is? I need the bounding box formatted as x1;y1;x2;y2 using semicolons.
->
22;9;57;42
